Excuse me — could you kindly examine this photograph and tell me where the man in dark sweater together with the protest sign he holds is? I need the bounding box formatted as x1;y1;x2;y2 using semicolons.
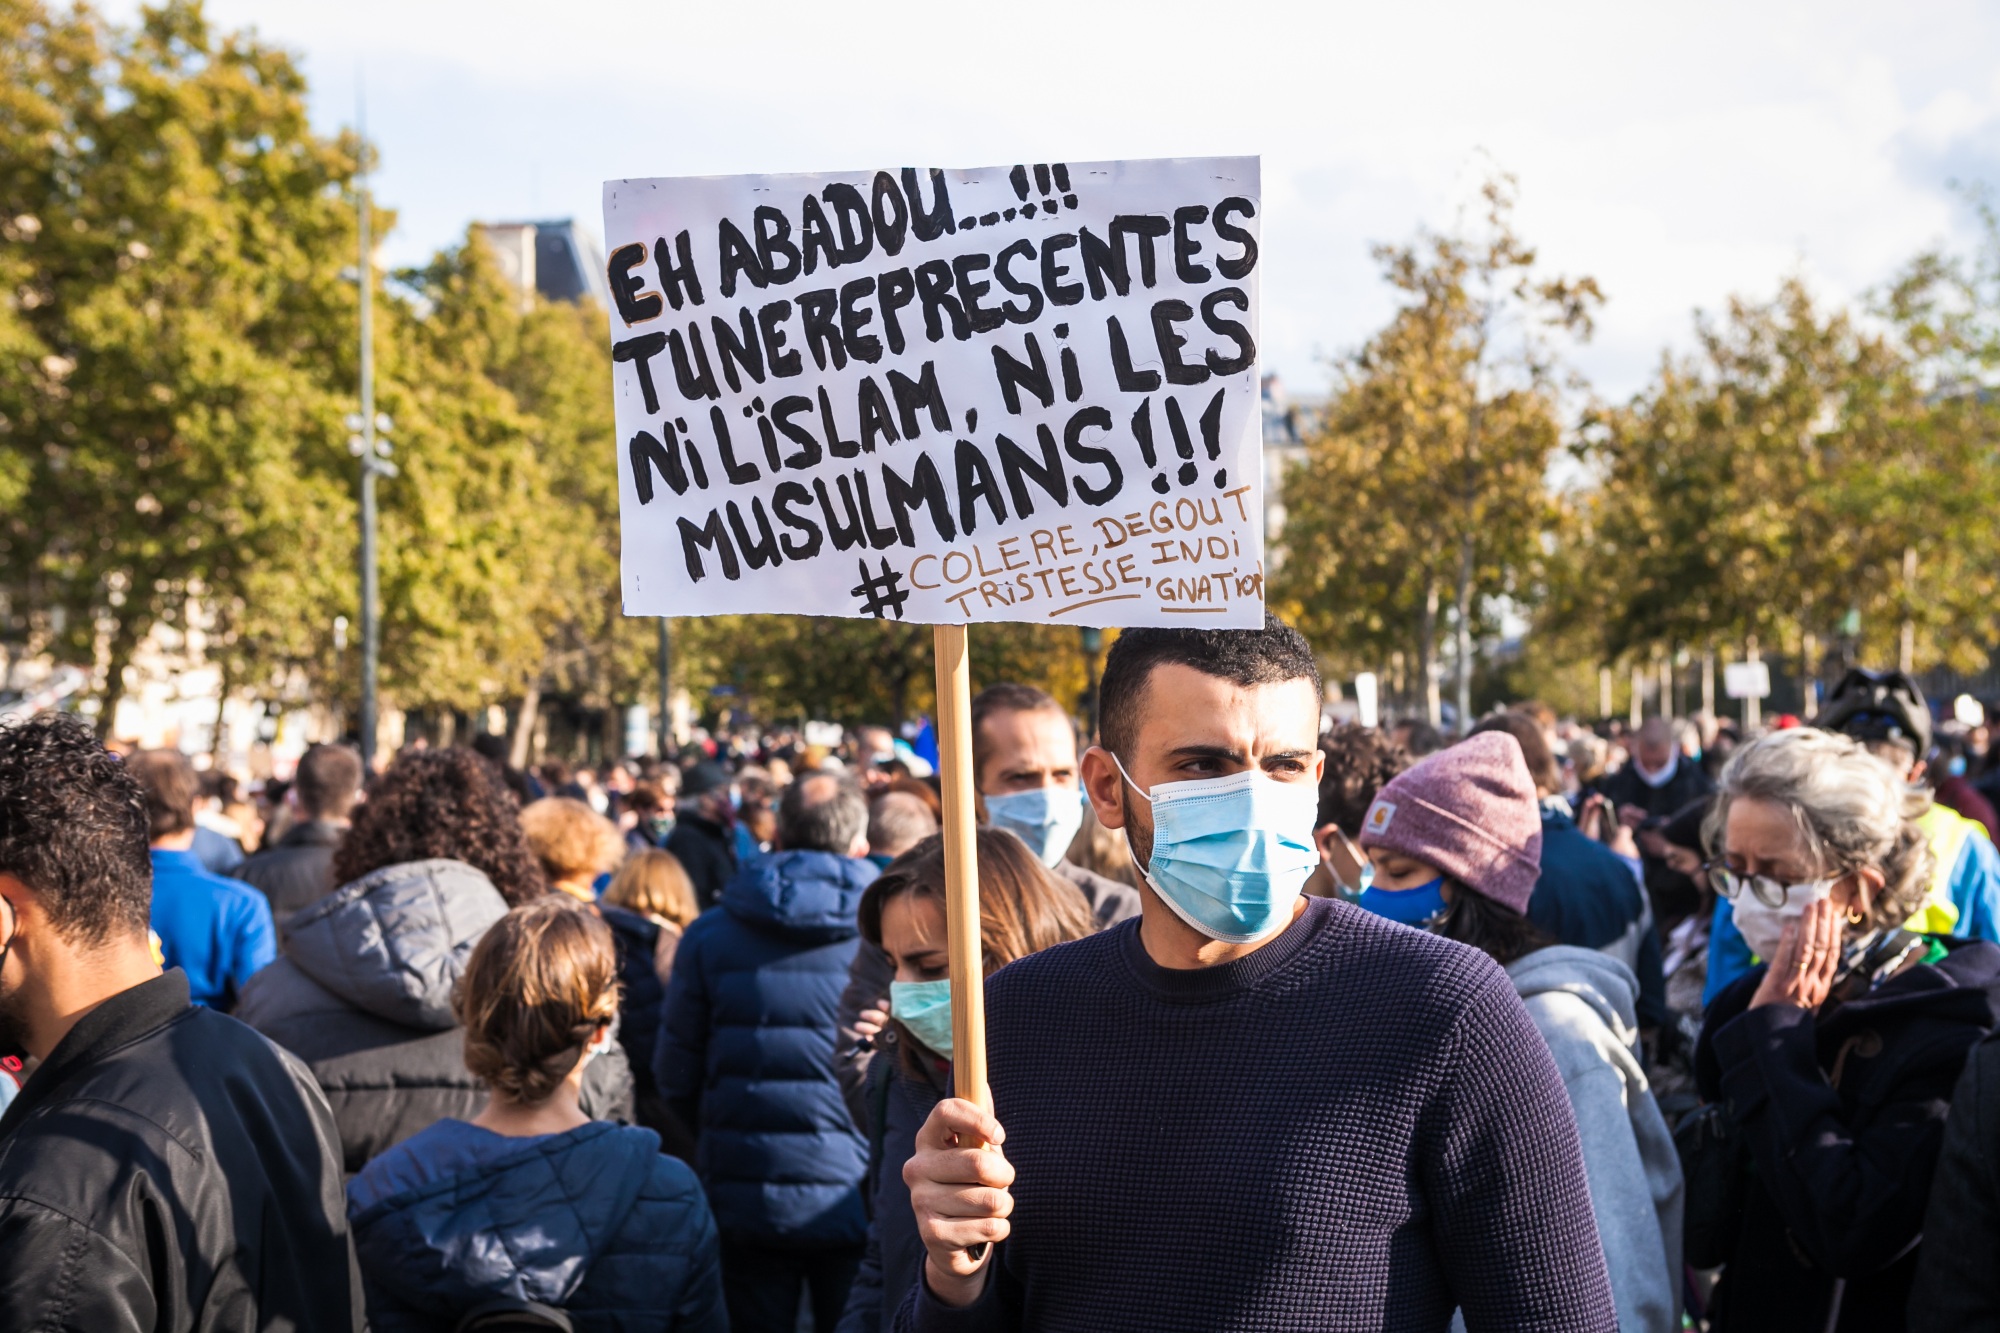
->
604;158;1616;1333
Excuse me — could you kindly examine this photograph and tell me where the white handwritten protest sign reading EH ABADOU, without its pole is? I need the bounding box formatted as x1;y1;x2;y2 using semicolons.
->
604;158;1264;626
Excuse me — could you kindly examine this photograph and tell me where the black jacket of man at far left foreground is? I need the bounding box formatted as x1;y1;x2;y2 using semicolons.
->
0;969;362;1333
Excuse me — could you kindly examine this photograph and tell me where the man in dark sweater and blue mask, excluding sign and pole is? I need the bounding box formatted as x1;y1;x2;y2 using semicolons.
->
896;616;1618;1333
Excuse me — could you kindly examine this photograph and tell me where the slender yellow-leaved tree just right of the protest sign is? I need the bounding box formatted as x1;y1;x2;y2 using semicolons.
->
1272;176;1602;723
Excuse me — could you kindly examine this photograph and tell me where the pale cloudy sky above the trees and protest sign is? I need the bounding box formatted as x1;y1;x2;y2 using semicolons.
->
110;0;2000;396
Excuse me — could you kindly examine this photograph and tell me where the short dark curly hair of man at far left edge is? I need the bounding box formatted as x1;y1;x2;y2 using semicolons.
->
0;713;154;945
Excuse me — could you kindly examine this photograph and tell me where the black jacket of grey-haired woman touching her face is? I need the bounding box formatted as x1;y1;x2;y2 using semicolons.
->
1694;941;2000;1333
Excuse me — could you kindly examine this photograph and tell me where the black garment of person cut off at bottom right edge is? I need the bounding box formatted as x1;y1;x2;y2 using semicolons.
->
1910;1037;2000;1333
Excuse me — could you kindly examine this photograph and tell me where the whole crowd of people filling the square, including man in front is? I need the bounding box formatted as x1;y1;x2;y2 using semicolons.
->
0;618;2000;1333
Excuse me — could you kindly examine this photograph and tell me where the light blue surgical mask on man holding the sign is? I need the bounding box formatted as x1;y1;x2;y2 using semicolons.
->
1112;755;1320;945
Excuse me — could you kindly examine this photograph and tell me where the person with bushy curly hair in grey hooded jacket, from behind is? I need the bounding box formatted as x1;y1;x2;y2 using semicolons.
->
236;749;632;1173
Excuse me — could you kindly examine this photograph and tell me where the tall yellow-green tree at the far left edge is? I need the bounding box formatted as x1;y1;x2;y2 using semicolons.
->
0;0;356;725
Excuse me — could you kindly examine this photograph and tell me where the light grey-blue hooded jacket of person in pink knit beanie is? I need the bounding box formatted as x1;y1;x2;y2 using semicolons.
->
1506;944;1682;1333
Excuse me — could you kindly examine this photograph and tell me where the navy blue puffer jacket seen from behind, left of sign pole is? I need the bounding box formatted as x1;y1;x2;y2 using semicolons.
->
654;851;876;1249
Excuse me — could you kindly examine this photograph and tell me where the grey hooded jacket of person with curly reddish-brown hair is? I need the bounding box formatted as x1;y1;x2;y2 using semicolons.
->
236;861;632;1173
